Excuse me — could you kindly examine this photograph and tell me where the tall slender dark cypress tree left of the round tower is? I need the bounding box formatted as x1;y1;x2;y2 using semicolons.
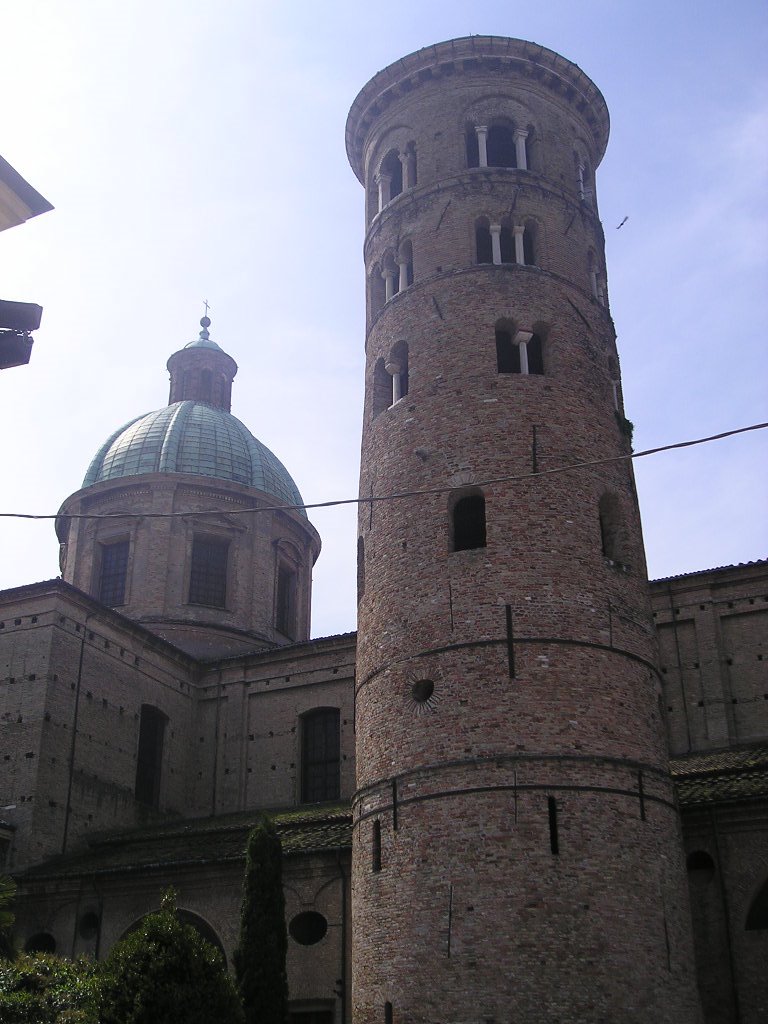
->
233;817;288;1024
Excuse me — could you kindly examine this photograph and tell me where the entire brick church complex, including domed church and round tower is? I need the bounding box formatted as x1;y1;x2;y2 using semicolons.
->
0;37;768;1024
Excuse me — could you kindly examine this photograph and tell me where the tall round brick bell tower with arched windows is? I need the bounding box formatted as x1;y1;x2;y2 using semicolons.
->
346;37;699;1024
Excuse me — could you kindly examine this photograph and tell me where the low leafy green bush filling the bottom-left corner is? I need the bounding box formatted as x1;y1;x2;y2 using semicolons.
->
0;953;98;1024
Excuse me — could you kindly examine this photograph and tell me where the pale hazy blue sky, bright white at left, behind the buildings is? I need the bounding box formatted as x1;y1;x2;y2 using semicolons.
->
0;0;768;636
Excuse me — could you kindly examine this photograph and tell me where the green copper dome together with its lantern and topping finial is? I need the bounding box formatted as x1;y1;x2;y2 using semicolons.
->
78;316;306;515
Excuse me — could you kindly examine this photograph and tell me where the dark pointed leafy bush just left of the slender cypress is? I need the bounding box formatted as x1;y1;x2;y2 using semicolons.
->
98;892;243;1024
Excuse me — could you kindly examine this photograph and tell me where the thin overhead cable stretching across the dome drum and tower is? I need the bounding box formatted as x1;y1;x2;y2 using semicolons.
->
0;423;768;519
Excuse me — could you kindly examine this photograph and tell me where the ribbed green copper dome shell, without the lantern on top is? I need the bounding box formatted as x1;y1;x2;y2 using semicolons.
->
83;400;306;515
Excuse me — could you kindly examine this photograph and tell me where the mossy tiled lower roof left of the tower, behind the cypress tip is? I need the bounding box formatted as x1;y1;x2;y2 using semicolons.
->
20;804;352;881
